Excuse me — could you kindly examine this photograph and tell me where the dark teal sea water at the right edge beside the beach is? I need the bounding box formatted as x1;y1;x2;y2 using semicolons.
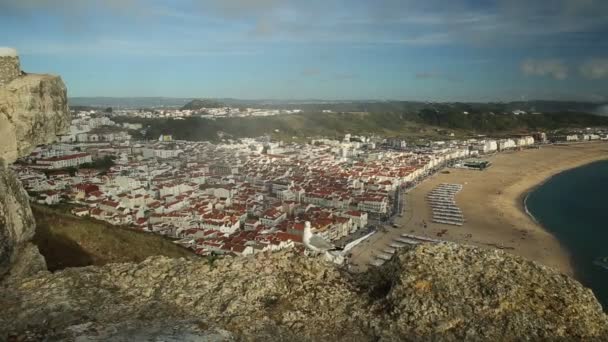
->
526;161;608;311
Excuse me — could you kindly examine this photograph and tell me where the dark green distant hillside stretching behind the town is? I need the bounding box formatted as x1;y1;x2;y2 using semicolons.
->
116;106;608;141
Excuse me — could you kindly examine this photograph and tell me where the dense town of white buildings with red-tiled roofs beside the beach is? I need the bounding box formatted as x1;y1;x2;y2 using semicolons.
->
13;112;608;256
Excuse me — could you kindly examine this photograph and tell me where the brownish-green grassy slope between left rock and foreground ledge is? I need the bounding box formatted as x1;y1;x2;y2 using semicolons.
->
32;205;195;271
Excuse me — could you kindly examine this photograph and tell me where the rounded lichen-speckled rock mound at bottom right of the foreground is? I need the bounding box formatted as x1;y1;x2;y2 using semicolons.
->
380;244;608;341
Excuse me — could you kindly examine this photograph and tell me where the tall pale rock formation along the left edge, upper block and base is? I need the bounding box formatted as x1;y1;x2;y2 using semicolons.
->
0;48;69;279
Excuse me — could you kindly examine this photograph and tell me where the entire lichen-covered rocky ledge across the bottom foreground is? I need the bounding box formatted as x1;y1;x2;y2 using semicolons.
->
0;243;608;341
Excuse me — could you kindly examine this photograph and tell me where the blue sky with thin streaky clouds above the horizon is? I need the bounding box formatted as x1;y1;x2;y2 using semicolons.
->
0;0;608;102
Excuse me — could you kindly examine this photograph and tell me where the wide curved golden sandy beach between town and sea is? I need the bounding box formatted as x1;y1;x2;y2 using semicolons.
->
352;142;608;276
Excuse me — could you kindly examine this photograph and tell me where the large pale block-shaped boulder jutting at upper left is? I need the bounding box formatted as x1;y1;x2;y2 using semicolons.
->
0;74;70;163
